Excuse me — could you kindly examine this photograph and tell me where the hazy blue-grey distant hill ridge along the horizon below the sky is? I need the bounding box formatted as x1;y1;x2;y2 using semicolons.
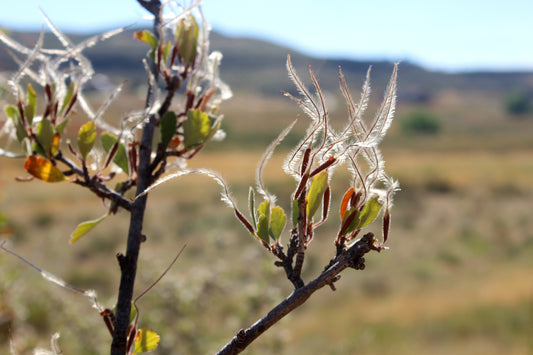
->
0;31;533;102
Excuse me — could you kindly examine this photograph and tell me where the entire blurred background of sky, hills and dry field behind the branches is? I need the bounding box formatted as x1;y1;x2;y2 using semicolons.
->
0;0;533;354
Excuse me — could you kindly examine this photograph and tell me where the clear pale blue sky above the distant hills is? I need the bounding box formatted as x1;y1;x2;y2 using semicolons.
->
0;0;533;71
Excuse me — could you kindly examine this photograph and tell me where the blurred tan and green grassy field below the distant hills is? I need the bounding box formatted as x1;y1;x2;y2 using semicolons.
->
0;80;533;354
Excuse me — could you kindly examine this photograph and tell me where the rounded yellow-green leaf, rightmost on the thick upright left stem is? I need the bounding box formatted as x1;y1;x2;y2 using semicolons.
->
183;110;220;150
